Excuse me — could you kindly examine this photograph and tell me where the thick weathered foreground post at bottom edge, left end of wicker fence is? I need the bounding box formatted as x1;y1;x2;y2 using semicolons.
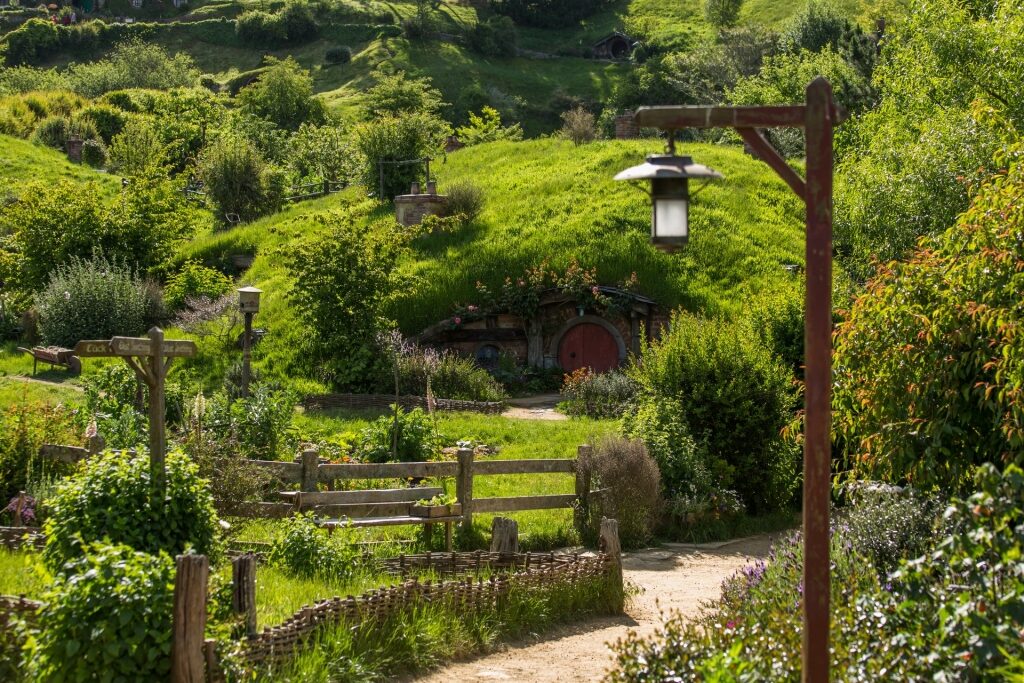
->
171;555;210;683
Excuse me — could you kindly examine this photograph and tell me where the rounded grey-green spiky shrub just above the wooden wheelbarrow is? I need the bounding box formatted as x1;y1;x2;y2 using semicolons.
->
36;256;148;347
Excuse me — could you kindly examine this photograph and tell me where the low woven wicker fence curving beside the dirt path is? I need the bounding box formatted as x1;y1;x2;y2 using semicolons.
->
240;553;615;665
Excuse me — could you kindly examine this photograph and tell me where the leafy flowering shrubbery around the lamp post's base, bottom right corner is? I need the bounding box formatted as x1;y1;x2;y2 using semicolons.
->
609;466;1024;683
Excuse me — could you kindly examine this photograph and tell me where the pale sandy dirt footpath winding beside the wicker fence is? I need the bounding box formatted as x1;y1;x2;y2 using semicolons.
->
407;536;775;683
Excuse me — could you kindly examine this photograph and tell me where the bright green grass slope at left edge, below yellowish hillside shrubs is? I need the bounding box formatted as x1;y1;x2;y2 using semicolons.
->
0;135;121;195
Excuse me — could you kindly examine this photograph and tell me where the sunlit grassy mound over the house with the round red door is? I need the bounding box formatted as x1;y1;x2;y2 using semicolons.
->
182;139;804;385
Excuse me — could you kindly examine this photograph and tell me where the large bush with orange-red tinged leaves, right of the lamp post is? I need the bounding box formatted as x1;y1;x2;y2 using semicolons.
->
833;164;1024;489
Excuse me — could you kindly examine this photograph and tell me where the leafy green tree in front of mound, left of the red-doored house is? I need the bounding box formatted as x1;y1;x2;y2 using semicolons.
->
285;212;412;389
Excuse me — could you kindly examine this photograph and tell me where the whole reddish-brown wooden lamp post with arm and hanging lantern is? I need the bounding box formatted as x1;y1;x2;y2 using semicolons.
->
616;77;846;683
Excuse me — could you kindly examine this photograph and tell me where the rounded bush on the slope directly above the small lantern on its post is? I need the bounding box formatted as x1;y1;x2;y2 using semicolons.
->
199;134;285;220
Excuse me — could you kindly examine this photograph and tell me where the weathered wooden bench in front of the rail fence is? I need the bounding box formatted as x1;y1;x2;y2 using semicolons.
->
281;486;462;551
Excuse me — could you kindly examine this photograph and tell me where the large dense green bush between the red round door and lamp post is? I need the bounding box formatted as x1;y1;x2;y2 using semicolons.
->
628;312;799;512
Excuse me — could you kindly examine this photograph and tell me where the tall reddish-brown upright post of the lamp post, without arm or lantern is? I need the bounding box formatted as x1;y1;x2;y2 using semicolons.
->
803;77;835;683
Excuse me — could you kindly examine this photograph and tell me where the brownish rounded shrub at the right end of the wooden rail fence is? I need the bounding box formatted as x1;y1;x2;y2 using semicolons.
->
577;437;662;548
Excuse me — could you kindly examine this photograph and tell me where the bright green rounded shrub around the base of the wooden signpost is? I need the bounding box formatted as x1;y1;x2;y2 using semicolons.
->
43;452;217;571
